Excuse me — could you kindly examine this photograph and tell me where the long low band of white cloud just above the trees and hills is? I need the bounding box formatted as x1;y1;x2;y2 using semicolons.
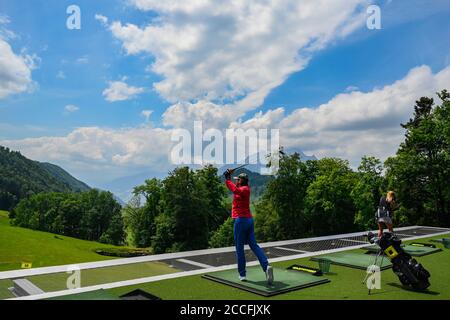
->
0;66;450;185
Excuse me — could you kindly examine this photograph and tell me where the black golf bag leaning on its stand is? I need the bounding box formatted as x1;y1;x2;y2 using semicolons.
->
368;232;430;291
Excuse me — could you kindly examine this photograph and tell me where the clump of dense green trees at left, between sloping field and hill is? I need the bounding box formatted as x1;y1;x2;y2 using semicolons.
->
11;190;125;244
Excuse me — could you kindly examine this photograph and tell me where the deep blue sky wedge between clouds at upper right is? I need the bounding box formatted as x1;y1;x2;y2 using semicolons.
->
264;1;450;112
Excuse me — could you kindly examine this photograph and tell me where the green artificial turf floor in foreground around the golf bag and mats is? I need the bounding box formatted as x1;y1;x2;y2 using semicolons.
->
109;232;450;300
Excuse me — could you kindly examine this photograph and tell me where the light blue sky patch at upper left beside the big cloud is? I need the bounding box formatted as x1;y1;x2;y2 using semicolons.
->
0;0;167;138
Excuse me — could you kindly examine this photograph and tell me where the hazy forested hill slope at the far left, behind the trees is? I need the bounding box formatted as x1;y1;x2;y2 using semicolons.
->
0;146;90;210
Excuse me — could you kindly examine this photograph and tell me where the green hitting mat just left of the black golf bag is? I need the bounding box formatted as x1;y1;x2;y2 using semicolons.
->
311;252;392;270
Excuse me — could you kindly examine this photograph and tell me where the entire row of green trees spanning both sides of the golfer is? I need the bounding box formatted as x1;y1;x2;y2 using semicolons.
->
7;90;450;253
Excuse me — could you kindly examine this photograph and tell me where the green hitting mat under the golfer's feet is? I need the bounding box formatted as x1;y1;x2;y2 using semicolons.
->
202;266;330;297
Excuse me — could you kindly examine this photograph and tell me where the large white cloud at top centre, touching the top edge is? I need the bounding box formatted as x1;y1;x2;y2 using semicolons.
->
110;0;366;105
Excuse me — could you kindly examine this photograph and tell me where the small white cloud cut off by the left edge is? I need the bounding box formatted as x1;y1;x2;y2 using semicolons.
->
0;38;38;99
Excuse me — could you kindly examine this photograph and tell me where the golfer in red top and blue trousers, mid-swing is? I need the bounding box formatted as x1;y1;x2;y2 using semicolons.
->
224;169;273;285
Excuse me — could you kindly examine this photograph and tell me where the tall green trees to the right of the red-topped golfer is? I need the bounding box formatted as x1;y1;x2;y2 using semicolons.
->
255;90;450;241
